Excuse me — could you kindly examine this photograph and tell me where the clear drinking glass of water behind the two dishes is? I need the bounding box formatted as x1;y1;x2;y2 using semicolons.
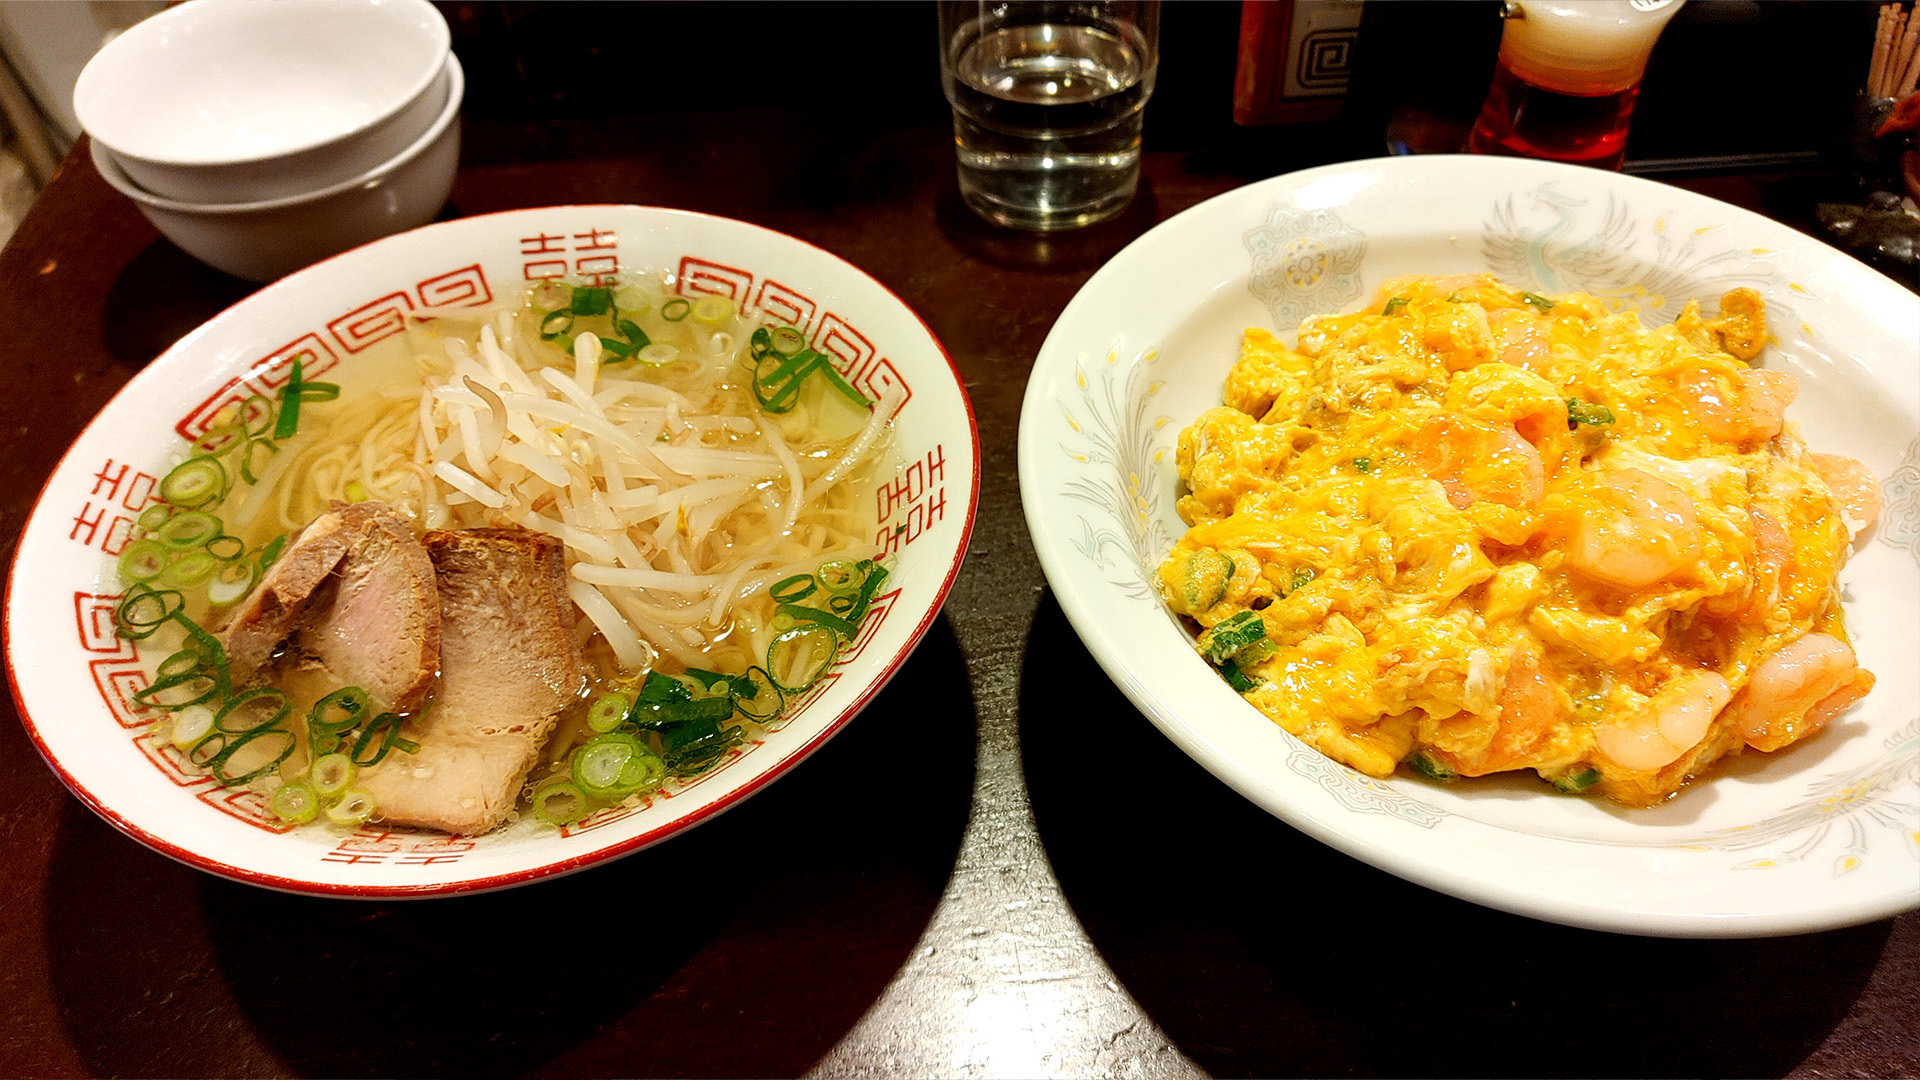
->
939;0;1160;231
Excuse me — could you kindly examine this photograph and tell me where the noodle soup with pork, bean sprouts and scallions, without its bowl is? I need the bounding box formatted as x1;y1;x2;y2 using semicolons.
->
115;277;893;836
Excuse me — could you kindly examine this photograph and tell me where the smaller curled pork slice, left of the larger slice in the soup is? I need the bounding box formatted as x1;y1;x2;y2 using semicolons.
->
221;502;440;711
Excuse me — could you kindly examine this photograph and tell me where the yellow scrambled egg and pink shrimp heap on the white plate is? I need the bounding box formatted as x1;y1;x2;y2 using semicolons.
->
1158;275;1878;807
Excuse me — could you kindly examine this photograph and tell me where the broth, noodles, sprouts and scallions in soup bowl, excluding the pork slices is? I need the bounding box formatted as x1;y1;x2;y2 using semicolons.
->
121;275;893;824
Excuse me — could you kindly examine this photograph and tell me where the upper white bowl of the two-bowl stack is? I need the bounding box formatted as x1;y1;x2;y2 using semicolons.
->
73;0;451;204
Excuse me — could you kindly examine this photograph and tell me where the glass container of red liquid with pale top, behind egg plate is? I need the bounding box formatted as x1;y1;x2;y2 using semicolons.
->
1467;0;1684;169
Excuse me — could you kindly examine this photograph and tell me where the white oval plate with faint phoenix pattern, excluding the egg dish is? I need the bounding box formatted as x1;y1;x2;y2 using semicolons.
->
1020;158;1920;936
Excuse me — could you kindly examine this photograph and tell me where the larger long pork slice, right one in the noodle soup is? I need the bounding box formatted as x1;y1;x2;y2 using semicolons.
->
359;528;586;836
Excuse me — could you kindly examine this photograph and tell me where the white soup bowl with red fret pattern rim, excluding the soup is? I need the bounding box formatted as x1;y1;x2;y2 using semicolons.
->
6;206;979;897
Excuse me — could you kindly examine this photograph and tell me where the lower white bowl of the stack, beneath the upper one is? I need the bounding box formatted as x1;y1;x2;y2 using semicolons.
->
92;54;467;281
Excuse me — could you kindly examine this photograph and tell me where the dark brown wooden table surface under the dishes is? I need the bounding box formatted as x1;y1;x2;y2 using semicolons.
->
0;115;1920;1076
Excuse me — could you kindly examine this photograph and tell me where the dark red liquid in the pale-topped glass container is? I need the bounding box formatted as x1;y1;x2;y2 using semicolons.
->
1467;56;1640;169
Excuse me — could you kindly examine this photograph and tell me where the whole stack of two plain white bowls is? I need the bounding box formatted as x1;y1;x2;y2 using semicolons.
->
73;0;467;281
